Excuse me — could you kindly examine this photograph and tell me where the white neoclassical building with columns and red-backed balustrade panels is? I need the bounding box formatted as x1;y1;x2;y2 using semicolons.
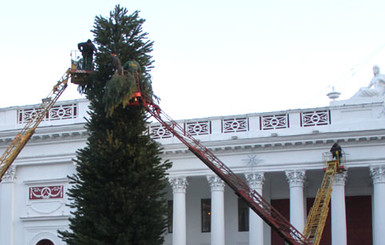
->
0;81;385;245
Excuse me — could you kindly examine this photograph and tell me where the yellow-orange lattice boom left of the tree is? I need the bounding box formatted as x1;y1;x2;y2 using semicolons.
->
0;69;70;182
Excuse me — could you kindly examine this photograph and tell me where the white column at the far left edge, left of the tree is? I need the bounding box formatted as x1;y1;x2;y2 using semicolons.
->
0;166;16;245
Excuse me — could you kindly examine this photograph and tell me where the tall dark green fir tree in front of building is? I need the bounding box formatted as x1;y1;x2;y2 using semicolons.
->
60;5;170;245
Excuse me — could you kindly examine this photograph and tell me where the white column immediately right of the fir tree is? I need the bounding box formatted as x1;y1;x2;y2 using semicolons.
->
169;177;188;245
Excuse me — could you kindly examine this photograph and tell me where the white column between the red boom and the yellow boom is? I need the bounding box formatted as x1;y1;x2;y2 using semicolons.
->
286;170;305;232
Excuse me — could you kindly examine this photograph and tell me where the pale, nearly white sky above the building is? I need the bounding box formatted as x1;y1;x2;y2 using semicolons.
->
0;0;385;119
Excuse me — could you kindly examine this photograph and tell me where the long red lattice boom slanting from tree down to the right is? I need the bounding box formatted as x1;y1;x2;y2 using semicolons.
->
131;91;312;245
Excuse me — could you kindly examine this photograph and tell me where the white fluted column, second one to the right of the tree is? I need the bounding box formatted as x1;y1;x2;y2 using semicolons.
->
207;176;225;245
